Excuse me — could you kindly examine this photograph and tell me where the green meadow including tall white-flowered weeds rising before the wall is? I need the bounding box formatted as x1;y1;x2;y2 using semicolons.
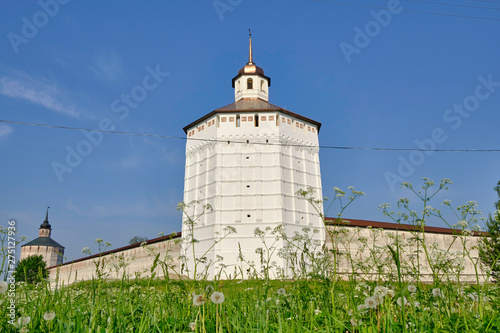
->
0;179;500;333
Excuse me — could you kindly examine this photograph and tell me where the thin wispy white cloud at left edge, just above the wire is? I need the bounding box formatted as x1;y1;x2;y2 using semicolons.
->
0;72;81;118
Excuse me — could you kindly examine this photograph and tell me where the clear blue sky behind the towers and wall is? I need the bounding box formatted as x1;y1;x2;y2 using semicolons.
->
0;0;500;260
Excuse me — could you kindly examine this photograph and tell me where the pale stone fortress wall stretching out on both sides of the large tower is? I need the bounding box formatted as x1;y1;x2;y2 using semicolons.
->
49;220;486;285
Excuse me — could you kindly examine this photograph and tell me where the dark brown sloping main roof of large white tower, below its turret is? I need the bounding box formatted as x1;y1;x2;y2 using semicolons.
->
184;99;321;133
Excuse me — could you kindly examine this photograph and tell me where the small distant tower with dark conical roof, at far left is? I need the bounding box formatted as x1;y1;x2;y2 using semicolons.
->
21;207;64;267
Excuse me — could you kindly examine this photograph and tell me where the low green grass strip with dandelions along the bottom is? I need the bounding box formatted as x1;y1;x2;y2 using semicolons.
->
0;280;500;332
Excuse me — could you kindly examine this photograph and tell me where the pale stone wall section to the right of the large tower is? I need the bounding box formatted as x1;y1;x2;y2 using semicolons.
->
327;226;486;282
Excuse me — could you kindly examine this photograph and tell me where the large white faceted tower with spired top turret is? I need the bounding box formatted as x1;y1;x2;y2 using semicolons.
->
182;35;325;278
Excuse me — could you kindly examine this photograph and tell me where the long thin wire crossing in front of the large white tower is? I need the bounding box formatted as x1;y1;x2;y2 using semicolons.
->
0;119;500;153
